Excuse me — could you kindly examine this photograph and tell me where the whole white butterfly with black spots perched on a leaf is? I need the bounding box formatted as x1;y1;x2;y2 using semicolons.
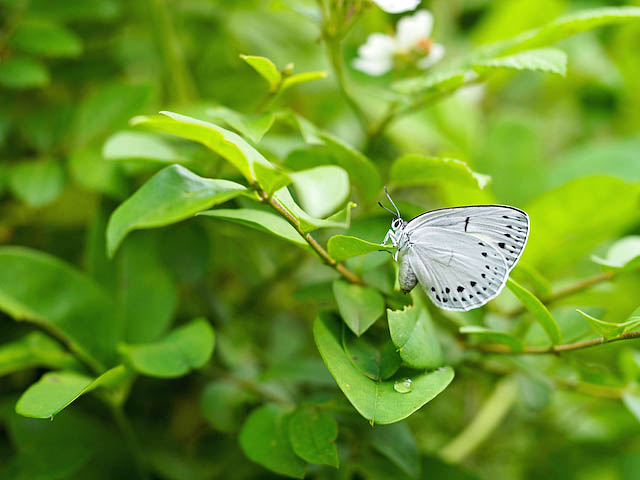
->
378;188;529;311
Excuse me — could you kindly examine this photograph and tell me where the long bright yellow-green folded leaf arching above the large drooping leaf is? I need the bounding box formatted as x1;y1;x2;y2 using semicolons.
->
131;112;271;181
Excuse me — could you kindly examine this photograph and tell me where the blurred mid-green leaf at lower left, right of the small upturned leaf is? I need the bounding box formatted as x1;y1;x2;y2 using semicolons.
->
120;318;215;378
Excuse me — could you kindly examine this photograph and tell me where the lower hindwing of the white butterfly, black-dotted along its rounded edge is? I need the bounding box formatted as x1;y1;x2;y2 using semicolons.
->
400;226;509;311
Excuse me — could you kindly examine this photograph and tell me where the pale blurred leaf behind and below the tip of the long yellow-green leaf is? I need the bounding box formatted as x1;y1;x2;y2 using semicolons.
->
102;131;188;165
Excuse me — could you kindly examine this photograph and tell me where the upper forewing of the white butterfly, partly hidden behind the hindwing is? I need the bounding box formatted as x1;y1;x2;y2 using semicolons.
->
405;205;529;271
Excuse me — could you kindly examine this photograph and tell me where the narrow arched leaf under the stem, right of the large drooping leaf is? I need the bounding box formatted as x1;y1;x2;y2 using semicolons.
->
198;208;307;248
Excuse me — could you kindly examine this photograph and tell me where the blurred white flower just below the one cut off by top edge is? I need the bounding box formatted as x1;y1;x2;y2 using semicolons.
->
353;9;444;76
